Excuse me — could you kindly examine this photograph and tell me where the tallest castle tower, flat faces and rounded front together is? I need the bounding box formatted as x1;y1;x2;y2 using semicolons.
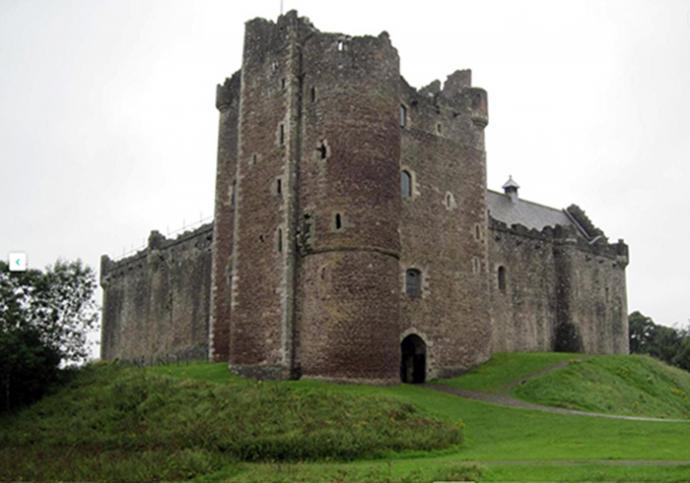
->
210;12;400;381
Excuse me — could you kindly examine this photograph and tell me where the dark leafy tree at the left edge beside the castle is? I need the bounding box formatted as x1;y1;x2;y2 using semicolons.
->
0;260;98;409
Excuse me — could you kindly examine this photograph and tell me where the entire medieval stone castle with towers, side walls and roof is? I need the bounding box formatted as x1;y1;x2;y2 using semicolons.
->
101;11;628;383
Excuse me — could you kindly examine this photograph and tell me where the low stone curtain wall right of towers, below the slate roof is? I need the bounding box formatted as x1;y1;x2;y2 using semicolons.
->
489;220;628;354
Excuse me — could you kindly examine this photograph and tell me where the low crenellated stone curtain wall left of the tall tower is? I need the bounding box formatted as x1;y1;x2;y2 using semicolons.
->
101;224;212;363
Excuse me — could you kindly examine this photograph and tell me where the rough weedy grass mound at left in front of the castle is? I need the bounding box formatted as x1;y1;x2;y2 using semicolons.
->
0;364;461;480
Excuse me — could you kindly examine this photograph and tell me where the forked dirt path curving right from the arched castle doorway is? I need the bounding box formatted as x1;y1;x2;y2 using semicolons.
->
424;361;690;423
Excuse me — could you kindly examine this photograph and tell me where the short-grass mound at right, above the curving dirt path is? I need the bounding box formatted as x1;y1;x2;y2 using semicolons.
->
514;356;690;418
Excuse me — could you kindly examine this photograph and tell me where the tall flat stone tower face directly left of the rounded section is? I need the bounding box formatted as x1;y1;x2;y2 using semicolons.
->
224;15;300;377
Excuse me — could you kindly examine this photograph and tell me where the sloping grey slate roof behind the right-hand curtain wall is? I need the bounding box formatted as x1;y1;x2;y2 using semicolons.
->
486;190;577;230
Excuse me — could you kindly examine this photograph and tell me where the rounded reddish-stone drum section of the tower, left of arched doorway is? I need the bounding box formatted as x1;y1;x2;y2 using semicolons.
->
296;23;400;382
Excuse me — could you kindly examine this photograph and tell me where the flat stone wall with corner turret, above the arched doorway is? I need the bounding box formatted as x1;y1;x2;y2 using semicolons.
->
398;71;491;378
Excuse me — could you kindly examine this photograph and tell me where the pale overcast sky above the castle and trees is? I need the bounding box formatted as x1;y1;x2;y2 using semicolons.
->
0;0;690;334
